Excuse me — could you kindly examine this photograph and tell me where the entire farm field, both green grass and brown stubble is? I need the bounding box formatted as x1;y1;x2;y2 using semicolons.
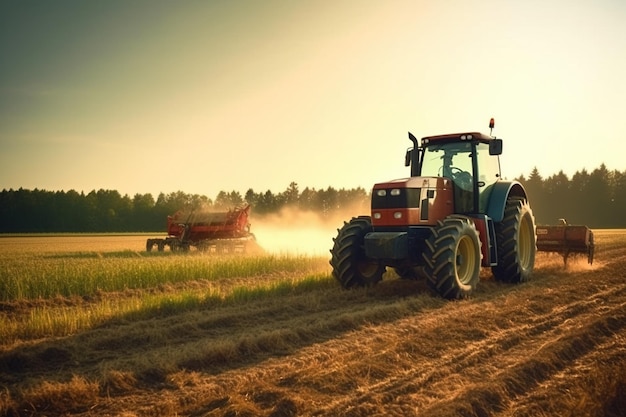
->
0;230;626;417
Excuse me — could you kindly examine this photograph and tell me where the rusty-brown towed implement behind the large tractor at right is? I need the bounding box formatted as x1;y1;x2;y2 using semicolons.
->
537;219;595;266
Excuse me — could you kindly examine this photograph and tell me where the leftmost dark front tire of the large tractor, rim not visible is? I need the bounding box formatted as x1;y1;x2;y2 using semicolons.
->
330;216;386;288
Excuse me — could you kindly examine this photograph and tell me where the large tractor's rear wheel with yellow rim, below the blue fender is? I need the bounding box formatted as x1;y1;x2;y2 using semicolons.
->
491;197;537;283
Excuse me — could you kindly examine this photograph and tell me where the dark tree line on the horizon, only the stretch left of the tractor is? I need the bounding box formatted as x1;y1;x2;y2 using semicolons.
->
0;182;369;233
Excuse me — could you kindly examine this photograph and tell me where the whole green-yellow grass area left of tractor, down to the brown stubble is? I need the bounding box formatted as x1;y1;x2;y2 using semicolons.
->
0;236;334;344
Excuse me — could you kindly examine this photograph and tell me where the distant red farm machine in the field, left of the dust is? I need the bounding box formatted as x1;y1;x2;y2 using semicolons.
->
146;205;256;253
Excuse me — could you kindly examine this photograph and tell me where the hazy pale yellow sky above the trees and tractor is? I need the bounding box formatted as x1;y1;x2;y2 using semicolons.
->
0;0;626;198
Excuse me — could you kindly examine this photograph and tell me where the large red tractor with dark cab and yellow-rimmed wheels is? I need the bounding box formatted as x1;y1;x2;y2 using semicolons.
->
330;119;537;299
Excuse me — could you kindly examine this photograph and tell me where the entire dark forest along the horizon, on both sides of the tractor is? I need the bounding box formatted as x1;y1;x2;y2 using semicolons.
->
0;164;626;233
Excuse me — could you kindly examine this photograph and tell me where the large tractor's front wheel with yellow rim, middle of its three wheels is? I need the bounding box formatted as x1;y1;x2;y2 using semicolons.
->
423;217;481;300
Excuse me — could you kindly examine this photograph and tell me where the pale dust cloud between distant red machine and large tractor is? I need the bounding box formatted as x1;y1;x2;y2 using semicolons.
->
250;208;367;256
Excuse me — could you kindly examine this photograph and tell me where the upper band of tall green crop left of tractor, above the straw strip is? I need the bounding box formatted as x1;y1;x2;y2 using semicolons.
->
0;251;325;302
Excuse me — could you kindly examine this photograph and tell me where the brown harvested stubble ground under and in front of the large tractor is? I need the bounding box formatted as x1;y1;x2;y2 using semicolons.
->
0;232;626;416
